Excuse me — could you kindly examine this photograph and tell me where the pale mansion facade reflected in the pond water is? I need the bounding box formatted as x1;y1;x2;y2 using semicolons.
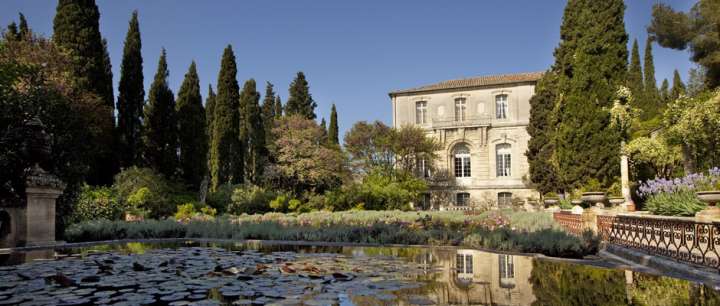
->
430;250;535;305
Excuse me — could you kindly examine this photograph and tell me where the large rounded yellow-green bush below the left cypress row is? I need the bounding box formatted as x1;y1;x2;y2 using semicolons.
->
113;167;196;218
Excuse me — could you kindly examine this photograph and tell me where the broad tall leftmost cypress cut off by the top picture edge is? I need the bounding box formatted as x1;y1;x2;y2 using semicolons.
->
53;0;117;184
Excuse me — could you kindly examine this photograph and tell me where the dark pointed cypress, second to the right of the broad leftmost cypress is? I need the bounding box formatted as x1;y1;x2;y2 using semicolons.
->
143;49;178;178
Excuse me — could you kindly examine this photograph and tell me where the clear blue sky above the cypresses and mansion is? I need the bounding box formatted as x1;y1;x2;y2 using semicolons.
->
0;0;695;134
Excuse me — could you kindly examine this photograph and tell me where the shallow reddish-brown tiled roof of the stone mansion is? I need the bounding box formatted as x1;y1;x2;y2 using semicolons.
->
390;72;543;96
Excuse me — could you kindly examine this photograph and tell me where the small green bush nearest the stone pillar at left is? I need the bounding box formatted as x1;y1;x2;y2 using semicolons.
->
70;185;125;223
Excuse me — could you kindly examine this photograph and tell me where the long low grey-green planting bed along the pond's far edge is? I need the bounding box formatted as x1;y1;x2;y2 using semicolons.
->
65;211;597;258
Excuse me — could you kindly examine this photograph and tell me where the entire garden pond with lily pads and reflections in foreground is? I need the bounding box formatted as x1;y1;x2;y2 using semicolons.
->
0;242;720;305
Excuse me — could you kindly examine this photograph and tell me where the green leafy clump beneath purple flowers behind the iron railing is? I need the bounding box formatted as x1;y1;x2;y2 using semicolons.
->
645;190;707;217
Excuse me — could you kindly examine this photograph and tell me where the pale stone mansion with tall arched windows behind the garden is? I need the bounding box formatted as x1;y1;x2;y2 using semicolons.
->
389;72;542;209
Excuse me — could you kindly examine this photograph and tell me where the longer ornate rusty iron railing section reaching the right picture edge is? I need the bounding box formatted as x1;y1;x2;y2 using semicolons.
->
598;214;720;269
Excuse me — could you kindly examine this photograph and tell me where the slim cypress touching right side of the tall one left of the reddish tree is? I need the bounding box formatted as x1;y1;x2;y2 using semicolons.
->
240;79;267;184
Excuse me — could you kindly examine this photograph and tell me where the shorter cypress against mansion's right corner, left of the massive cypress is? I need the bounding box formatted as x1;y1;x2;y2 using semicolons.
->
525;70;563;194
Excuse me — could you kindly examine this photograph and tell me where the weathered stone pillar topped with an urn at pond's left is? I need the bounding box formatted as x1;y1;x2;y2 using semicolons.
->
22;166;65;246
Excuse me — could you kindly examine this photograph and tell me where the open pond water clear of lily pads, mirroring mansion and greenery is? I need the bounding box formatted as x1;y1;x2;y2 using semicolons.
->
0;242;720;305
